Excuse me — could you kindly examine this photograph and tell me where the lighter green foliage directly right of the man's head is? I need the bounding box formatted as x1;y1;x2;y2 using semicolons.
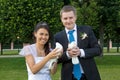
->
73;0;99;39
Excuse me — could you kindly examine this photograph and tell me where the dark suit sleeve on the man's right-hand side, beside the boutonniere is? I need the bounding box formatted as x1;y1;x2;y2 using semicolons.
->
84;27;102;58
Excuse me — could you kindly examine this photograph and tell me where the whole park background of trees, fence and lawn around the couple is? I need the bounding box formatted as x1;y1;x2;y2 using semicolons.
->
0;0;120;80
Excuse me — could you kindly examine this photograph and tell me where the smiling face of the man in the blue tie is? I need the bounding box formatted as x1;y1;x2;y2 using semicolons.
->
61;11;76;30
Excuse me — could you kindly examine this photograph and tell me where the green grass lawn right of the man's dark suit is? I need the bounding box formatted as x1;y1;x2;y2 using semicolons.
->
96;55;120;80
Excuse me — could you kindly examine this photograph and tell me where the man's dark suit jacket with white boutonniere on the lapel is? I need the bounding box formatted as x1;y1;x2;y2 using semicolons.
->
54;26;101;80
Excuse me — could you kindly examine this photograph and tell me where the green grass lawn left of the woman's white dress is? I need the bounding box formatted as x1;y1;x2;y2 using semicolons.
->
0;58;27;80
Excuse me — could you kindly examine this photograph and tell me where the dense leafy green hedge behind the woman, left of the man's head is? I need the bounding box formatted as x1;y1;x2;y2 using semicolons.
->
0;0;63;42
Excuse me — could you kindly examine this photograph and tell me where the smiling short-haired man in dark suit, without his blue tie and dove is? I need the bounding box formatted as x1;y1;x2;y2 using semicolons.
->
54;5;101;80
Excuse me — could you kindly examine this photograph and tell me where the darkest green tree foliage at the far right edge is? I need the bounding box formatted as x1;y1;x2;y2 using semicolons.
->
96;0;120;41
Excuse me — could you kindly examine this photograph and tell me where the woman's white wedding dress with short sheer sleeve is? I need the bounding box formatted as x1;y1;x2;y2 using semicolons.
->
19;44;51;80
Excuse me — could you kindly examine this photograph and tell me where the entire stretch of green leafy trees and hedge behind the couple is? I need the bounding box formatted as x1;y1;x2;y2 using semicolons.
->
0;0;120;50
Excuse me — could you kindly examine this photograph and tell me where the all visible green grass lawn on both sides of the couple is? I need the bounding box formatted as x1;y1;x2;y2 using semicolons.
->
0;55;120;80
